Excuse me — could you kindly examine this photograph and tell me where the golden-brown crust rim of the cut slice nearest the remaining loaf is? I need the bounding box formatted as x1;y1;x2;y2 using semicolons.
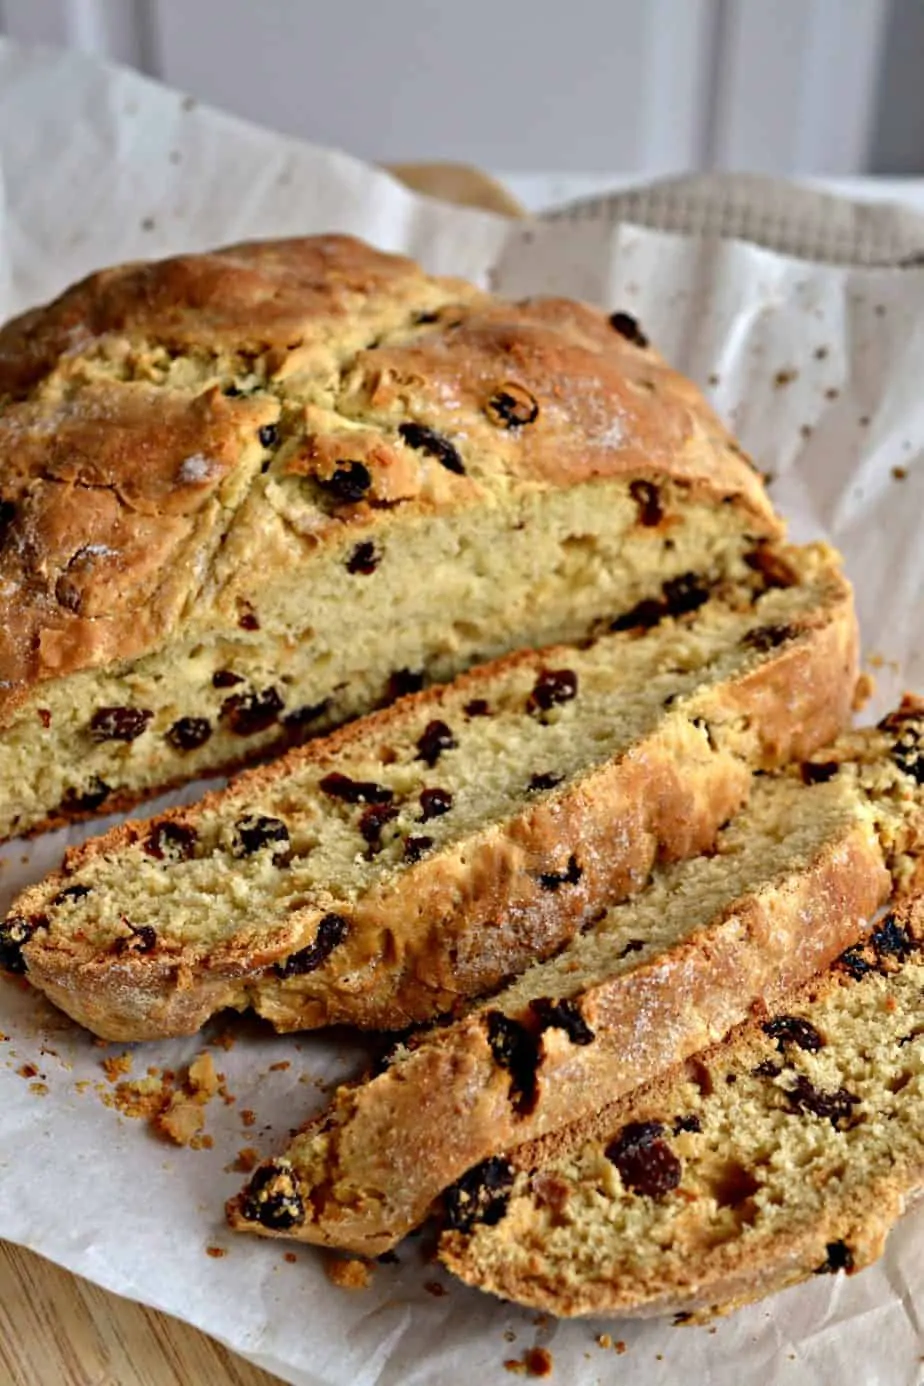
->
14;572;856;1040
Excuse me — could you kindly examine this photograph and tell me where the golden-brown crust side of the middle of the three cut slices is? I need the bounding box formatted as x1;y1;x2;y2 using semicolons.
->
229;823;891;1256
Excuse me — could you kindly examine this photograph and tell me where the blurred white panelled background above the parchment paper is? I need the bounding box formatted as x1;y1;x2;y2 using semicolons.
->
0;0;897;173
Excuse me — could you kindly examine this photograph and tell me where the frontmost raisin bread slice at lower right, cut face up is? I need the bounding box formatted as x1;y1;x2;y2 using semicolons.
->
439;897;924;1318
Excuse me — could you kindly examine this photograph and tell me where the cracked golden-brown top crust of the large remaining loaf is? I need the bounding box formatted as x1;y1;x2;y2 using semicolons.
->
0;237;780;721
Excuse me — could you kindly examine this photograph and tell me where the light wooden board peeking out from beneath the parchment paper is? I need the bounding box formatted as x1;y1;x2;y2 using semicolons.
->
0;164;524;1386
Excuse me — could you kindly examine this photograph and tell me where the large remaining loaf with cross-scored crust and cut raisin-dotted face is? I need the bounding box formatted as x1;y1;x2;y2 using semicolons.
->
0;236;781;837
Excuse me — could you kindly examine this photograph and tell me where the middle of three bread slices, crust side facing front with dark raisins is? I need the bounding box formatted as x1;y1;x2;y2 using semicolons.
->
230;704;924;1253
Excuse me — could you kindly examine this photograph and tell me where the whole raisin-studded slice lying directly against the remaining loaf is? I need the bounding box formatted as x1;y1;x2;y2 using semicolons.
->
0;550;856;1040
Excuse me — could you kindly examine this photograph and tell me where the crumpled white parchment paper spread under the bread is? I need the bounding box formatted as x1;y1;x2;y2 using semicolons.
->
0;44;924;1386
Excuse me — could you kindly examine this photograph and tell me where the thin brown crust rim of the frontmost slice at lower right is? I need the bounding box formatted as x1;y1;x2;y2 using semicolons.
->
439;894;924;1322
